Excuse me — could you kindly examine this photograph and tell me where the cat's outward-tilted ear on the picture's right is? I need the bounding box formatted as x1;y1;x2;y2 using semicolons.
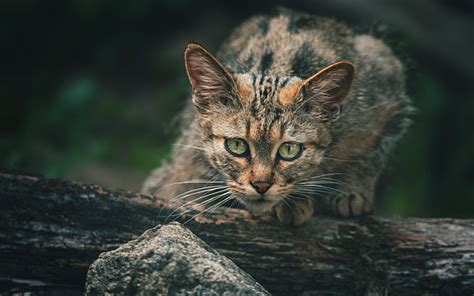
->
298;61;355;118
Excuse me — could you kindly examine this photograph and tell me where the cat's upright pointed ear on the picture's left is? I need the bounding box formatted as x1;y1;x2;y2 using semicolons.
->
184;43;235;111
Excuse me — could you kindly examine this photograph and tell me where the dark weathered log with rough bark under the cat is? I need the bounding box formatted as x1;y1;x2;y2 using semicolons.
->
0;174;474;295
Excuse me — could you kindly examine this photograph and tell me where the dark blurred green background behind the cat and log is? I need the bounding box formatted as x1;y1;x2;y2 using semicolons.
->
0;0;474;218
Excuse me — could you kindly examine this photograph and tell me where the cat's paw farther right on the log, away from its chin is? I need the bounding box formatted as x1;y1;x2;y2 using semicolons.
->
335;193;374;218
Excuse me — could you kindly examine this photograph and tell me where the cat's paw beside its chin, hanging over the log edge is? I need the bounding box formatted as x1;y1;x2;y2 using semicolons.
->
273;200;314;226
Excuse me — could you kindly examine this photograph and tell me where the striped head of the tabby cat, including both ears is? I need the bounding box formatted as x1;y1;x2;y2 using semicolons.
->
185;44;354;212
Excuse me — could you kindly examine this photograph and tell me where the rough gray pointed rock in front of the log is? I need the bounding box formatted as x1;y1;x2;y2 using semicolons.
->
86;222;270;295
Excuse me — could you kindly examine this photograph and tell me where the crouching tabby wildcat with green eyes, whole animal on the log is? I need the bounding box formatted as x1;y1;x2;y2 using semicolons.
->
143;9;412;225
